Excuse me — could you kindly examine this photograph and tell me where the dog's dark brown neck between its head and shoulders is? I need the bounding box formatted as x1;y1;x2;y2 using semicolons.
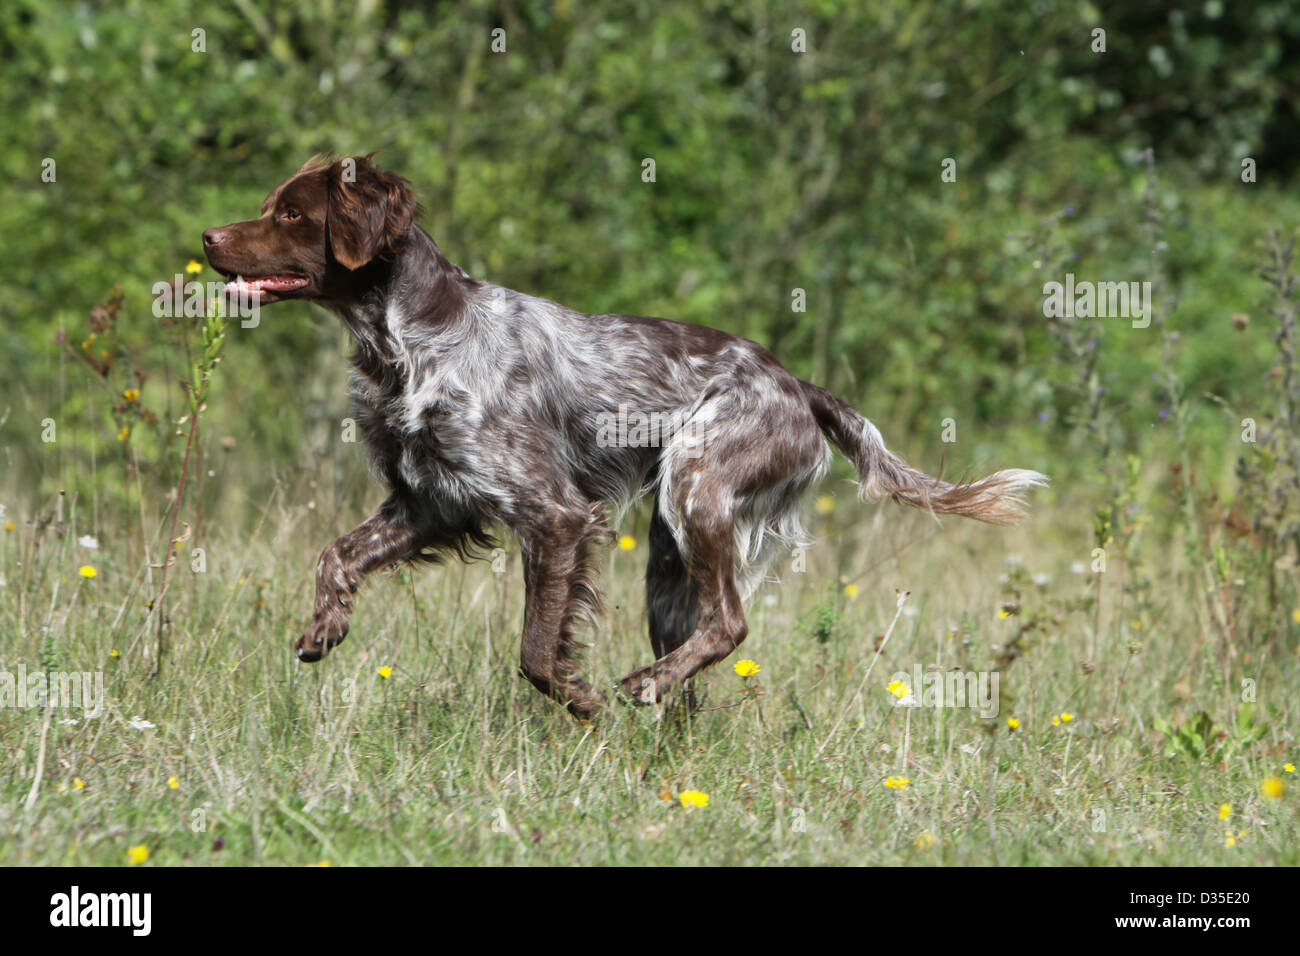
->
324;225;478;362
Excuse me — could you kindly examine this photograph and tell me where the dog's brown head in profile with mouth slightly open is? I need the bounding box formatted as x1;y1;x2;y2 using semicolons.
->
203;156;417;306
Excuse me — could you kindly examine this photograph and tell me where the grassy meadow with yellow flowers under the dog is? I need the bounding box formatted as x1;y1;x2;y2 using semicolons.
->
0;480;1300;865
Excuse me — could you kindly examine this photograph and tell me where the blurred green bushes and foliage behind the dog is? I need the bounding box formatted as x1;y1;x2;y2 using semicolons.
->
0;0;1300;507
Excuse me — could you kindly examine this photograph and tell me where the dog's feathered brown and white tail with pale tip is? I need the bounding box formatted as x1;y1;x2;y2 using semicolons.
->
800;381;1048;524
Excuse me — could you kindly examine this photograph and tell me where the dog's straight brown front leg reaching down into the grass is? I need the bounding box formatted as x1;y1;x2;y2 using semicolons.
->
519;506;608;717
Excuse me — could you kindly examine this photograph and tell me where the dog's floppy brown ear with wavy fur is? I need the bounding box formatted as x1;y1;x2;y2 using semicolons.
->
325;156;416;269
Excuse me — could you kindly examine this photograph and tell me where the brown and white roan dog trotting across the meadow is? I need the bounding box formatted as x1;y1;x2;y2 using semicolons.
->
203;153;1047;718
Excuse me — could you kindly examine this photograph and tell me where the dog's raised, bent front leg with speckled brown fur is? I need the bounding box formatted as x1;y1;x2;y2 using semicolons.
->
295;498;426;662
